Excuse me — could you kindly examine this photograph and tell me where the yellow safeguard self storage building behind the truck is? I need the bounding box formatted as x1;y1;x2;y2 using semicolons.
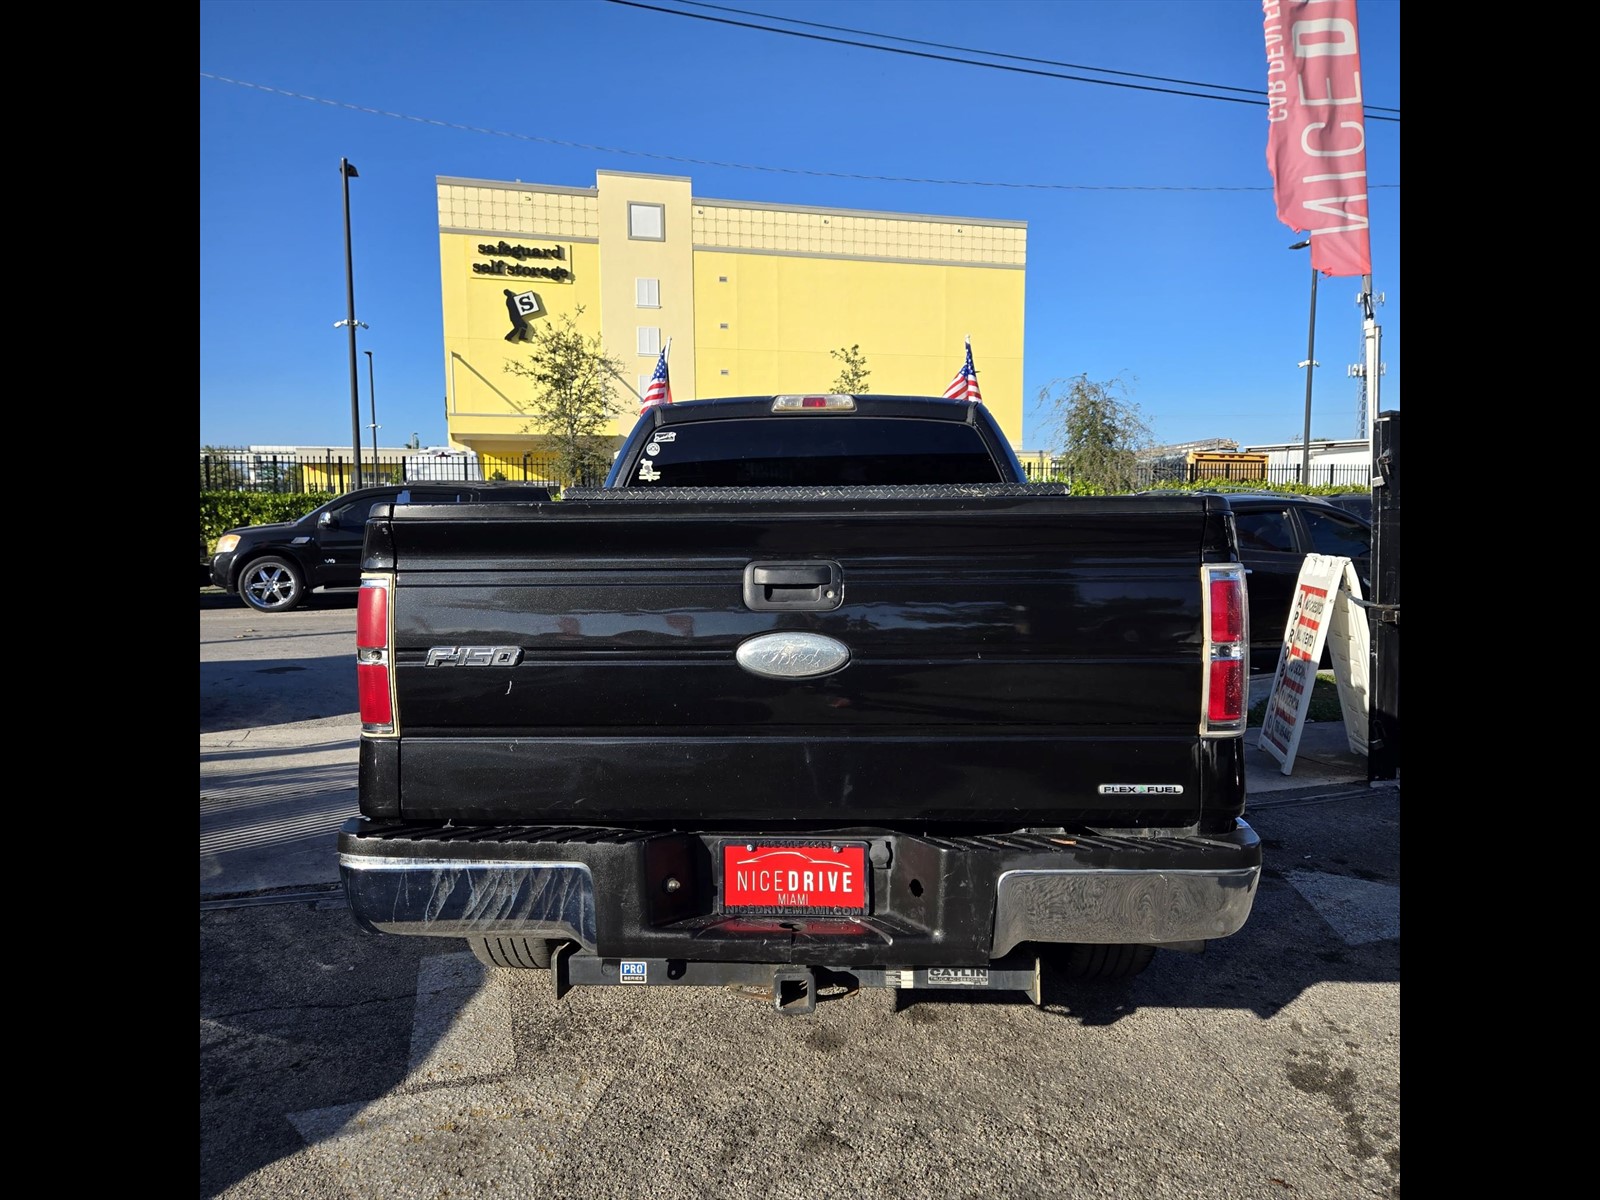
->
437;171;1027;475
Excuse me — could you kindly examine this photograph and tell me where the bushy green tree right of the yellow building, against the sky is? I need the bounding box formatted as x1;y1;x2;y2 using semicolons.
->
1038;373;1152;493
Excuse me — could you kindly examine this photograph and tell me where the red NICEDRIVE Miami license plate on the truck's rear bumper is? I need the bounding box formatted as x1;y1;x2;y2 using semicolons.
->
722;842;867;912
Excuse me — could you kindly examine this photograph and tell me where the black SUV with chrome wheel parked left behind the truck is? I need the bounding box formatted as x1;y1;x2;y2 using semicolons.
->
211;482;550;613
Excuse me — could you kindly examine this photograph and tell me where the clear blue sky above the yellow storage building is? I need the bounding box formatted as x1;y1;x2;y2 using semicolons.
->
198;0;1400;450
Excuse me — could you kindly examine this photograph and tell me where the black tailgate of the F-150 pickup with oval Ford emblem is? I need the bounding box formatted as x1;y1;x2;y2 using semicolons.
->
360;485;1240;829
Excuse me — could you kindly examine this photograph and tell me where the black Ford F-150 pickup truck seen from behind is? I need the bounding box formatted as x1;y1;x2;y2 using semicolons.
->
339;395;1261;1013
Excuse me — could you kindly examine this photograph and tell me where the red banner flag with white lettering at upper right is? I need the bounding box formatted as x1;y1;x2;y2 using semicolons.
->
1261;0;1373;275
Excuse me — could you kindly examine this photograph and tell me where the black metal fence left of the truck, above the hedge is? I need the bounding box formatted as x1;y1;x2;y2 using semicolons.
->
200;448;605;494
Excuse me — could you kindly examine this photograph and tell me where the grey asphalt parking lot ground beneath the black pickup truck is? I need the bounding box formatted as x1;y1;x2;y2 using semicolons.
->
200;590;1400;1200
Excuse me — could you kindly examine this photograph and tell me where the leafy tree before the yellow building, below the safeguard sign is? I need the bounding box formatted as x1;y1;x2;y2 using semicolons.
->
506;306;622;488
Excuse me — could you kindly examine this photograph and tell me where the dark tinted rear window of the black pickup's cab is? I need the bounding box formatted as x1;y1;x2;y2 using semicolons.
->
619;416;1006;488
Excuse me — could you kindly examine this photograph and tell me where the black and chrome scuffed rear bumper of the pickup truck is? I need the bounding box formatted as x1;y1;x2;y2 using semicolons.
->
339;819;1261;966
